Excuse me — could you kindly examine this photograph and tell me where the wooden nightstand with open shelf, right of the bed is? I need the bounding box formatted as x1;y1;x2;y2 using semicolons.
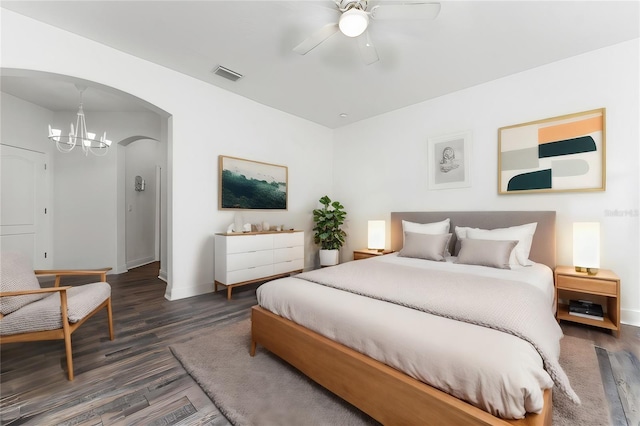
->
554;266;620;337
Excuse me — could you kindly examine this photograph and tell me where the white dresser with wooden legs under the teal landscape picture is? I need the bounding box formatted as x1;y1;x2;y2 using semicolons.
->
214;231;304;299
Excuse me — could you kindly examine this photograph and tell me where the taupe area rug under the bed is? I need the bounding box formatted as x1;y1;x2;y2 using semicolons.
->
171;320;610;426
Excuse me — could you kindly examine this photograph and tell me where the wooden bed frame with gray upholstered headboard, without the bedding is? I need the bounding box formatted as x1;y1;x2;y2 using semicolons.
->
251;211;555;426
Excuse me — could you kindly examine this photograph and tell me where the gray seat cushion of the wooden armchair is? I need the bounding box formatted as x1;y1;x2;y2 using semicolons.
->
0;282;111;335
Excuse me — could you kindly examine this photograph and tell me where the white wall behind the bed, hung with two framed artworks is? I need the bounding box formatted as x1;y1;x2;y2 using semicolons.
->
333;39;640;325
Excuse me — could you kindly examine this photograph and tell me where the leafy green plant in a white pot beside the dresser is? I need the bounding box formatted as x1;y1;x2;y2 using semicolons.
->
313;195;347;266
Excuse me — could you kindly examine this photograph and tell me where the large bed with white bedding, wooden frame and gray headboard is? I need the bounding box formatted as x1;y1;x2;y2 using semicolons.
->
251;212;577;425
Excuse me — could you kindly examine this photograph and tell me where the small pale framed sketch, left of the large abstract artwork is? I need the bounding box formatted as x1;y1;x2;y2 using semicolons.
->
427;131;472;189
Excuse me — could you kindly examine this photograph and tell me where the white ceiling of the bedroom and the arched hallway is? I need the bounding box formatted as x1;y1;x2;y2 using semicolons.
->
0;0;640;128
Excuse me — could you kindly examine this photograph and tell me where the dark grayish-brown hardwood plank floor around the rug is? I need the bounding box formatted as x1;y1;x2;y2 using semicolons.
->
0;263;640;426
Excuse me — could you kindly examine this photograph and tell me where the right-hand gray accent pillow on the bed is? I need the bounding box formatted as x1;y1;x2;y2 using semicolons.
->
456;238;518;269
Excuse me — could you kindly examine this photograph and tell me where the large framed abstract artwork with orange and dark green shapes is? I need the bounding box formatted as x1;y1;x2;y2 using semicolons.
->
498;108;606;194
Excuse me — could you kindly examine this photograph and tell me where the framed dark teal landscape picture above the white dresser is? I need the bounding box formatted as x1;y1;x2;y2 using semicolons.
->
218;155;289;210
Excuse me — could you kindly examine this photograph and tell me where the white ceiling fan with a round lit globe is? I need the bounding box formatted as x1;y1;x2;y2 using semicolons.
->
293;0;440;65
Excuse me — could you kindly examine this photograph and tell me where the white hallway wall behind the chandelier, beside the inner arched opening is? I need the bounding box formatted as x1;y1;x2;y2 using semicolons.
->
48;111;160;273
